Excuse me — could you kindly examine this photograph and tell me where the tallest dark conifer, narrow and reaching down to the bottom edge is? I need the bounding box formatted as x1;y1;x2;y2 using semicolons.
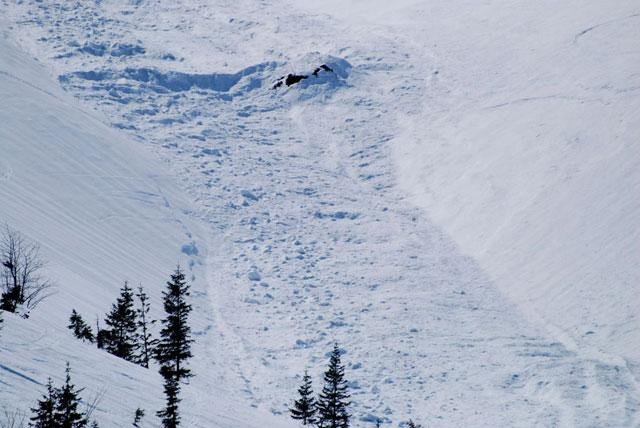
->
155;266;193;428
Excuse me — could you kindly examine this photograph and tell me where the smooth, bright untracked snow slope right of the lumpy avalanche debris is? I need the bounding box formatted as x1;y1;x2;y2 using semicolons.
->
312;1;640;364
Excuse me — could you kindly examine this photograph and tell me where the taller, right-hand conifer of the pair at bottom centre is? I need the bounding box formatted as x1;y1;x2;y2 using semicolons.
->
317;344;351;428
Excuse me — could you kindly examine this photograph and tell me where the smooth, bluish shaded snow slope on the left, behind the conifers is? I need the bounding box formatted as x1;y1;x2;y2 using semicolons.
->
0;28;292;427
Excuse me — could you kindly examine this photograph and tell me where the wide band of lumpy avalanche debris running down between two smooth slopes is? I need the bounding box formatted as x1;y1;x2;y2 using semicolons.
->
0;1;639;426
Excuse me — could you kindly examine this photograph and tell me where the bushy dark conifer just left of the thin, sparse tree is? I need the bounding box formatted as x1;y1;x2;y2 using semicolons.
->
103;281;137;361
